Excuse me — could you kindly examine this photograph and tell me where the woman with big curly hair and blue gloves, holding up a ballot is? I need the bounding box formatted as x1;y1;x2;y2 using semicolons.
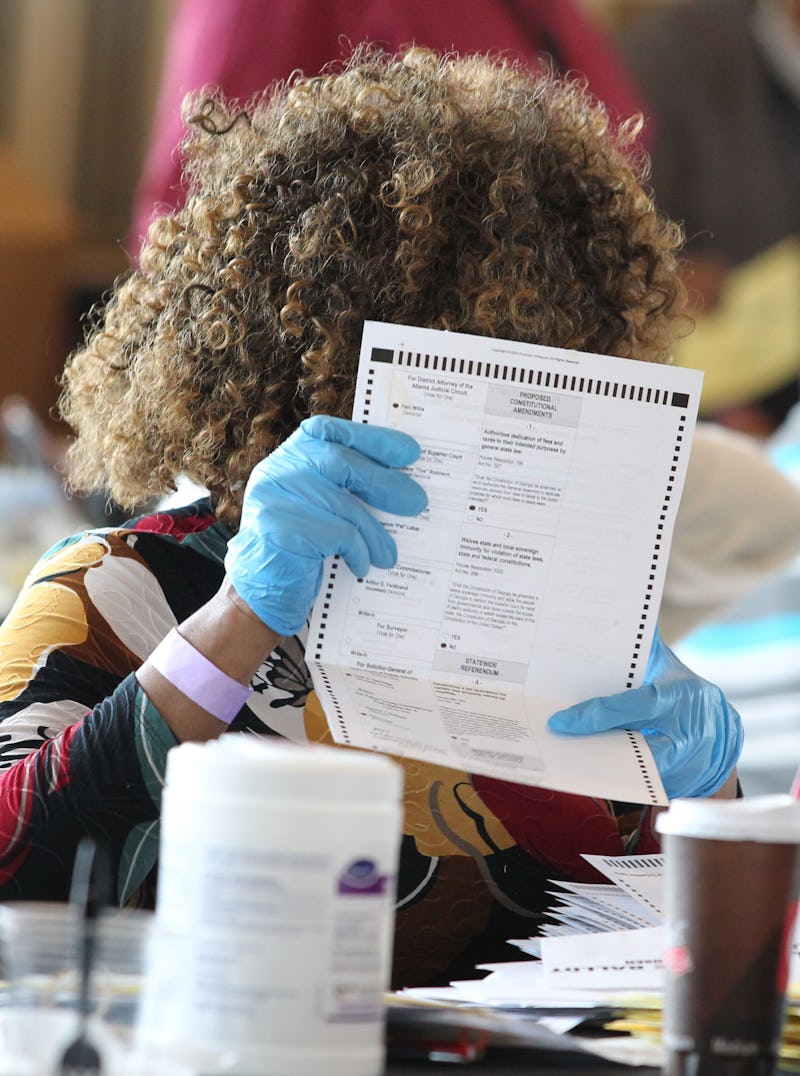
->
0;49;741;985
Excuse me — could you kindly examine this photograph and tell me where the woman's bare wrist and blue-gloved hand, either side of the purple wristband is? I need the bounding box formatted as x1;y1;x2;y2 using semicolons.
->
137;415;427;740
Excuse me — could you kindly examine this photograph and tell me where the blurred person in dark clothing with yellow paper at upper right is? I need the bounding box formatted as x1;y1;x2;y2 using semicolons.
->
617;0;800;437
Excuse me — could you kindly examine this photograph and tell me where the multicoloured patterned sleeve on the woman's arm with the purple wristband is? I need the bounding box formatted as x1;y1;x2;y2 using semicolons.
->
0;532;176;901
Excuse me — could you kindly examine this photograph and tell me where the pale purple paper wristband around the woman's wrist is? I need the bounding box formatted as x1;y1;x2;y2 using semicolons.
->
148;627;253;725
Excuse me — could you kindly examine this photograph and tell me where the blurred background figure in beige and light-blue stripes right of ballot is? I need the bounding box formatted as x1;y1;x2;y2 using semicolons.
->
671;413;800;794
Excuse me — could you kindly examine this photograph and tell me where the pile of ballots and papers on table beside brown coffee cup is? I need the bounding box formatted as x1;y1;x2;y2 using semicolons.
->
390;855;800;1072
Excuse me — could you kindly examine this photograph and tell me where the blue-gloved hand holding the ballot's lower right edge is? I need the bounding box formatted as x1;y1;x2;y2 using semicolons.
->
547;632;743;799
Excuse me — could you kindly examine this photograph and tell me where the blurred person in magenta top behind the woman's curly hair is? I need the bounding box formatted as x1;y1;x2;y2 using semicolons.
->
128;0;642;254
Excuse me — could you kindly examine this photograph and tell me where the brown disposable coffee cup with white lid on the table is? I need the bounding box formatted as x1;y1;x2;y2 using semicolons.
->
656;795;800;1076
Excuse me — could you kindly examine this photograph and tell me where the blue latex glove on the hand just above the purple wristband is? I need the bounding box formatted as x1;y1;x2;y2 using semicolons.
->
225;415;427;635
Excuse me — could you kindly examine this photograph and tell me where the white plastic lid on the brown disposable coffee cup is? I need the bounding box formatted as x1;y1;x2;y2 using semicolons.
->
656;795;800;845
